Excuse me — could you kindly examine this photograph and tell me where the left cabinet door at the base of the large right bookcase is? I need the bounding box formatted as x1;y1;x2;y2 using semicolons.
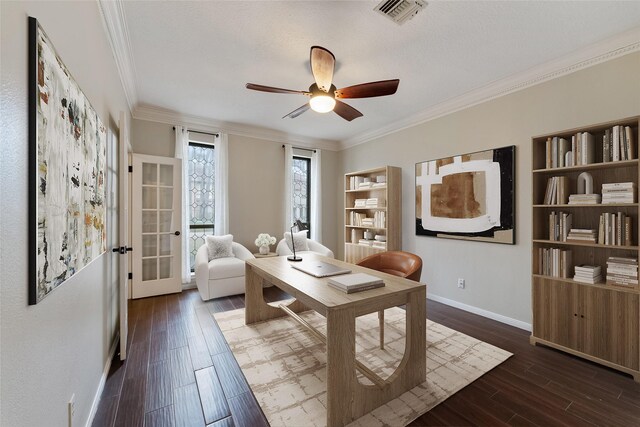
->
533;277;579;349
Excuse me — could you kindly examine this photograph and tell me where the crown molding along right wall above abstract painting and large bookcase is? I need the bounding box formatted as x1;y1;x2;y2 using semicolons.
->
340;27;640;150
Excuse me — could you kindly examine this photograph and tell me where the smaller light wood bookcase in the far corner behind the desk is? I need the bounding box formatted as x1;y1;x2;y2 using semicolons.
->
344;166;402;264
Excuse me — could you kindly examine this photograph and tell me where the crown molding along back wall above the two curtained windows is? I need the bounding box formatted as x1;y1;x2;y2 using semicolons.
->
131;105;340;151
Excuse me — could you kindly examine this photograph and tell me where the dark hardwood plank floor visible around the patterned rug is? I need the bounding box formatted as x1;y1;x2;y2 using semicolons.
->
93;288;640;427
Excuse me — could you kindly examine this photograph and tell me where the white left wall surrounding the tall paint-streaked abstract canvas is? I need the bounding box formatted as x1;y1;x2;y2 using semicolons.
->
0;1;128;426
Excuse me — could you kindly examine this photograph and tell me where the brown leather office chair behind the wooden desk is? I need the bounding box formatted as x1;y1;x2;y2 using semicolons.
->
356;251;422;349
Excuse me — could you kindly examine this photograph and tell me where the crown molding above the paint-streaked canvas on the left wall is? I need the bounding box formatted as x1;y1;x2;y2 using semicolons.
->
97;0;138;111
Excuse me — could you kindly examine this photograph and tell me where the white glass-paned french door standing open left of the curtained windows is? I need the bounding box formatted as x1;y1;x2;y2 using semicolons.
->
131;154;182;299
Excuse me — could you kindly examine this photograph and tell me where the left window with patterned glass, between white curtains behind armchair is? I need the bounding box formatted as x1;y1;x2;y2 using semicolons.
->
188;142;215;271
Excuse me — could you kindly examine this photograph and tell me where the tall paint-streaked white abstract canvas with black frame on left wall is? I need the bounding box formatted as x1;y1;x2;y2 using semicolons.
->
28;17;107;304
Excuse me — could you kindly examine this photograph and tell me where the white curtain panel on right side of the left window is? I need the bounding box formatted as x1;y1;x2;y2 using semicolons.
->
213;132;229;236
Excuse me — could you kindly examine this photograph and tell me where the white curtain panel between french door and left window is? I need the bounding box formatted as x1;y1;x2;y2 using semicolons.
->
175;126;191;283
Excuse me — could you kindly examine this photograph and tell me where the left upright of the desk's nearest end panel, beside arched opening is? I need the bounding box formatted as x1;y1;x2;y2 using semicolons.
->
327;309;357;427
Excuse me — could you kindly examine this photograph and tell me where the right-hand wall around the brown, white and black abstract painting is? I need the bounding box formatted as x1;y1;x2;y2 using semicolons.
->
336;53;640;324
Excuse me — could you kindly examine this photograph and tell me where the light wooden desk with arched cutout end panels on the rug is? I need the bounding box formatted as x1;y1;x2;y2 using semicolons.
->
245;254;426;427
